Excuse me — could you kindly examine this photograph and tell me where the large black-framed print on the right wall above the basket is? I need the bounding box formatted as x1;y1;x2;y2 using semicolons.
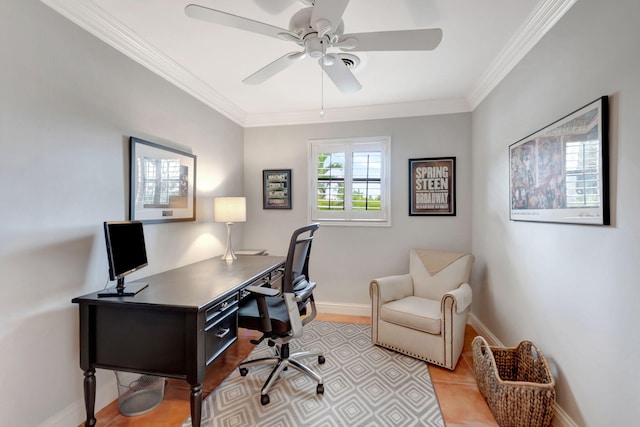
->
509;96;610;225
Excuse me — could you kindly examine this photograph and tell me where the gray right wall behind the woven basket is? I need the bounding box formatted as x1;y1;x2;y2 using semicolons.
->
472;0;640;427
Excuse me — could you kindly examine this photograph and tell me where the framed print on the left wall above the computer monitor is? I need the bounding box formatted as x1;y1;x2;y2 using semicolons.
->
129;137;196;223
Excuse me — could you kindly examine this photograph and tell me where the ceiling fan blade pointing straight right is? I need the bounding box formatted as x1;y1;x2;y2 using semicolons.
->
336;28;442;52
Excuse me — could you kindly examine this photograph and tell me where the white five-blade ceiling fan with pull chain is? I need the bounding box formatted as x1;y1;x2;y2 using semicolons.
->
185;0;442;93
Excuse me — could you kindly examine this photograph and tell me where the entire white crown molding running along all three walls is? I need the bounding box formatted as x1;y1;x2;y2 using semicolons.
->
40;0;577;127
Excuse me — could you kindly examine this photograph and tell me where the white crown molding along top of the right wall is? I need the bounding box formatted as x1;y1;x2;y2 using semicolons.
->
468;0;577;110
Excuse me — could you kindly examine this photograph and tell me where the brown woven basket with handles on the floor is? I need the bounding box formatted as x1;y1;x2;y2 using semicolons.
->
472;336;556;427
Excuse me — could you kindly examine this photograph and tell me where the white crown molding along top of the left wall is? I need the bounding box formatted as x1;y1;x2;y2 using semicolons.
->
40;0;246;126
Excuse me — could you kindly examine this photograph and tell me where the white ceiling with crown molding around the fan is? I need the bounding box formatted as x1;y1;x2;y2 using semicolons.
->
42;0;576;127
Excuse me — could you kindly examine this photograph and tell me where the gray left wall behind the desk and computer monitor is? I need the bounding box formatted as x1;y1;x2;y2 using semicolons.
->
0;0;243;426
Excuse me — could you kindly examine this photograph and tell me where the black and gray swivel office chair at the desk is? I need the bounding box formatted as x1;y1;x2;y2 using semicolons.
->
238;224;325;405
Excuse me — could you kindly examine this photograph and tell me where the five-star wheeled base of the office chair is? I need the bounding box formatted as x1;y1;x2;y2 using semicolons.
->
238;343;325;405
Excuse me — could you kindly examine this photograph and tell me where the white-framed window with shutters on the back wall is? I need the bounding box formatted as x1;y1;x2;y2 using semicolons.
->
309;137;390;225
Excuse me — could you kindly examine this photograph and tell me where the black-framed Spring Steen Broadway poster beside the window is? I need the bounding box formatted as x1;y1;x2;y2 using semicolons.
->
409;157;456;216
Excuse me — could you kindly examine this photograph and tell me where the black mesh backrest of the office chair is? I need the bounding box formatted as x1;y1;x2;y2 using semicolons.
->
282;223;320;293
